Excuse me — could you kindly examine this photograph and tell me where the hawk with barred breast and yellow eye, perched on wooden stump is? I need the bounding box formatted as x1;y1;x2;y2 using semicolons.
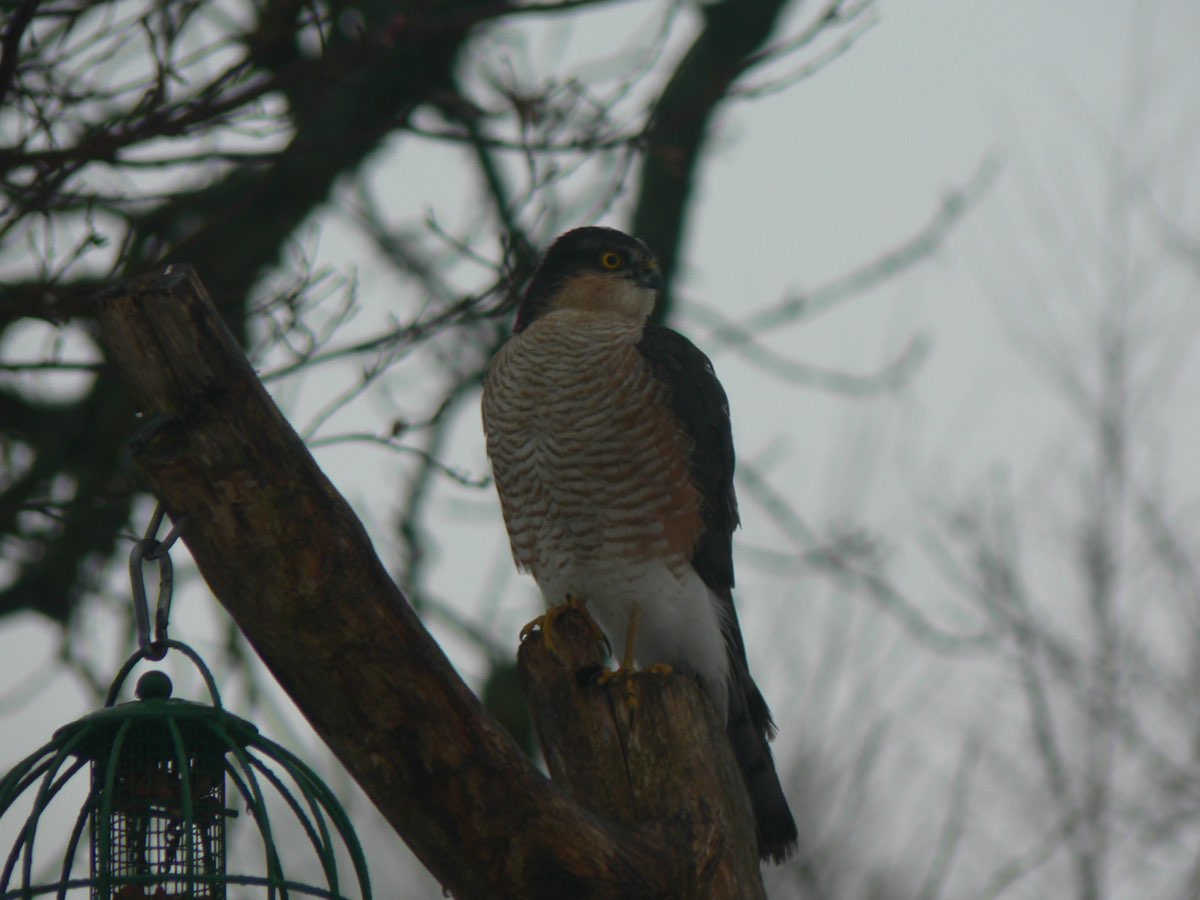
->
482;227;797;862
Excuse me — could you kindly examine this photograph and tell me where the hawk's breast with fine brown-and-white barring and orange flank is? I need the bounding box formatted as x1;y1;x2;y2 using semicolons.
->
482;310;702;583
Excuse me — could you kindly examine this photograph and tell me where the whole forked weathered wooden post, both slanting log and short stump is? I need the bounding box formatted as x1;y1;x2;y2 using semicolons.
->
96;268;762;899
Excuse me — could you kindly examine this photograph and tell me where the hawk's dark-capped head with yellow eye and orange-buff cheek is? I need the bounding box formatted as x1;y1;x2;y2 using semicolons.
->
514;227;662;331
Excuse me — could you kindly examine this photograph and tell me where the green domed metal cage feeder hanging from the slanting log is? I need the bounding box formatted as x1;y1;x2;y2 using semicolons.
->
0;641;371;900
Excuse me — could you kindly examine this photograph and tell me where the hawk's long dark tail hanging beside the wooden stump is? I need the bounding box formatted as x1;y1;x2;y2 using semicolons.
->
725;653;797;863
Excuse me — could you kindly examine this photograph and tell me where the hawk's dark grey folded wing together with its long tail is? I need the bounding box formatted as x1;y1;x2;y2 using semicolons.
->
637;325;797;862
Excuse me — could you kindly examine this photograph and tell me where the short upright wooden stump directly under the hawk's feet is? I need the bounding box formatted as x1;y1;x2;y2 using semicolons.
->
518;611;766;900
